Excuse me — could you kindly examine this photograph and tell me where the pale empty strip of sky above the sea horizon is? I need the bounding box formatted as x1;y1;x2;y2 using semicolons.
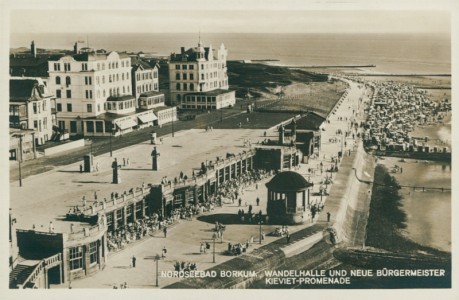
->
10;6;451;34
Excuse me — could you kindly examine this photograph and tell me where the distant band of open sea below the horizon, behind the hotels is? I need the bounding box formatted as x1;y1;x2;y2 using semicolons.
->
10;33;451;74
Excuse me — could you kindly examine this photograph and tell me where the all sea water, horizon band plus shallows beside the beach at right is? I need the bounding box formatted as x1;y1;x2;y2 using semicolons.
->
10;33;451;251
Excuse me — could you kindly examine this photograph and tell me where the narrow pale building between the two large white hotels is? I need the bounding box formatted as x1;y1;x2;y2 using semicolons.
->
131;57;159;103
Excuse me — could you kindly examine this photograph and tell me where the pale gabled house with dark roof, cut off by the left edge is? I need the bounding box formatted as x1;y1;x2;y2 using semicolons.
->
9;77;56;145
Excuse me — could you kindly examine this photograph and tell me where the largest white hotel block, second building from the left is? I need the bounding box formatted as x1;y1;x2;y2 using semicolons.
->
48;49;132;135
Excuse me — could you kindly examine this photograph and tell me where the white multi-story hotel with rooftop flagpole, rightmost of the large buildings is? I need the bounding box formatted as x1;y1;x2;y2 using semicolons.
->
169;42;236;109
